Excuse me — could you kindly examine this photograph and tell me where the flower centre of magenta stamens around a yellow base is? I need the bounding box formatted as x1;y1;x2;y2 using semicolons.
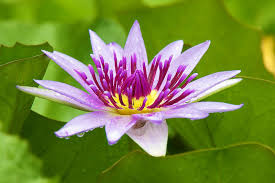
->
75;52;197;115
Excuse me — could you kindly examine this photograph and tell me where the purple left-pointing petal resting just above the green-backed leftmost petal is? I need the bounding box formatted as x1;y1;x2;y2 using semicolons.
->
34;80;105;110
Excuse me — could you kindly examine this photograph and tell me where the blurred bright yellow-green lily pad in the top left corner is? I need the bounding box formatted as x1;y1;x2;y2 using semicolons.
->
0;0;98;24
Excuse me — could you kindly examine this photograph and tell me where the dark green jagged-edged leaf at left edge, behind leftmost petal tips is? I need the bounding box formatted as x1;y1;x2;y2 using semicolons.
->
0;43;51;133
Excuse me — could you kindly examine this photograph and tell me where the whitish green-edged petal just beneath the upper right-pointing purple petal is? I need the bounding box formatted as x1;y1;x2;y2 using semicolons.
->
190;78;242;102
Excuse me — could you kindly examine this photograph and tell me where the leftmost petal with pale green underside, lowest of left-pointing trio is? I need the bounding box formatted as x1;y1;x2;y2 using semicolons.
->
16;86;94;111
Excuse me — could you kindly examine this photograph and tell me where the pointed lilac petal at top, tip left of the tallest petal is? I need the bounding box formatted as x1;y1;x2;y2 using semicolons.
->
89;30;114;69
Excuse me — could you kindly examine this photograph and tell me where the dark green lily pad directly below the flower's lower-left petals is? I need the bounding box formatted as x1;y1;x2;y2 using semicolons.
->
22;112;135;183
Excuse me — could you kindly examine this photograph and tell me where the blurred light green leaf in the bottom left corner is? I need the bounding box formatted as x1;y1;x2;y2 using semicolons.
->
0;132;53;183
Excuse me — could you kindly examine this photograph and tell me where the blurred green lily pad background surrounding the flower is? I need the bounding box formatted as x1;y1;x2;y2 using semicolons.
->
0;0;275;183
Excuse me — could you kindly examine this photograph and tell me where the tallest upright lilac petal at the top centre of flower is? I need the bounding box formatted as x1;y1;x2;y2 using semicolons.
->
124;20;148;72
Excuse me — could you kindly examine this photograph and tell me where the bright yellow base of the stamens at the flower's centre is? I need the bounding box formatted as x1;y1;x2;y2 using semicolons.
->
109;90;161;115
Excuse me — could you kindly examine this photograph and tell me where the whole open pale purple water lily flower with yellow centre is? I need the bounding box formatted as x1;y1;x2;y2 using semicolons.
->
17;21;242;156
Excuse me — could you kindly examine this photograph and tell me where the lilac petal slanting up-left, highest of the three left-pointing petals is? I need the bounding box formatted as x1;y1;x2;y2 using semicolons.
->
42;50;95;95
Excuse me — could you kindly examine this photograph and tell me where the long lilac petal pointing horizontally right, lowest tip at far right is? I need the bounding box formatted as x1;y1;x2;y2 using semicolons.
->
183;102;243;113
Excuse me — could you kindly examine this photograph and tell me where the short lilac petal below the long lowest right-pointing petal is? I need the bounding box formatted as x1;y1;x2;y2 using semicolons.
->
162;104;208;120
